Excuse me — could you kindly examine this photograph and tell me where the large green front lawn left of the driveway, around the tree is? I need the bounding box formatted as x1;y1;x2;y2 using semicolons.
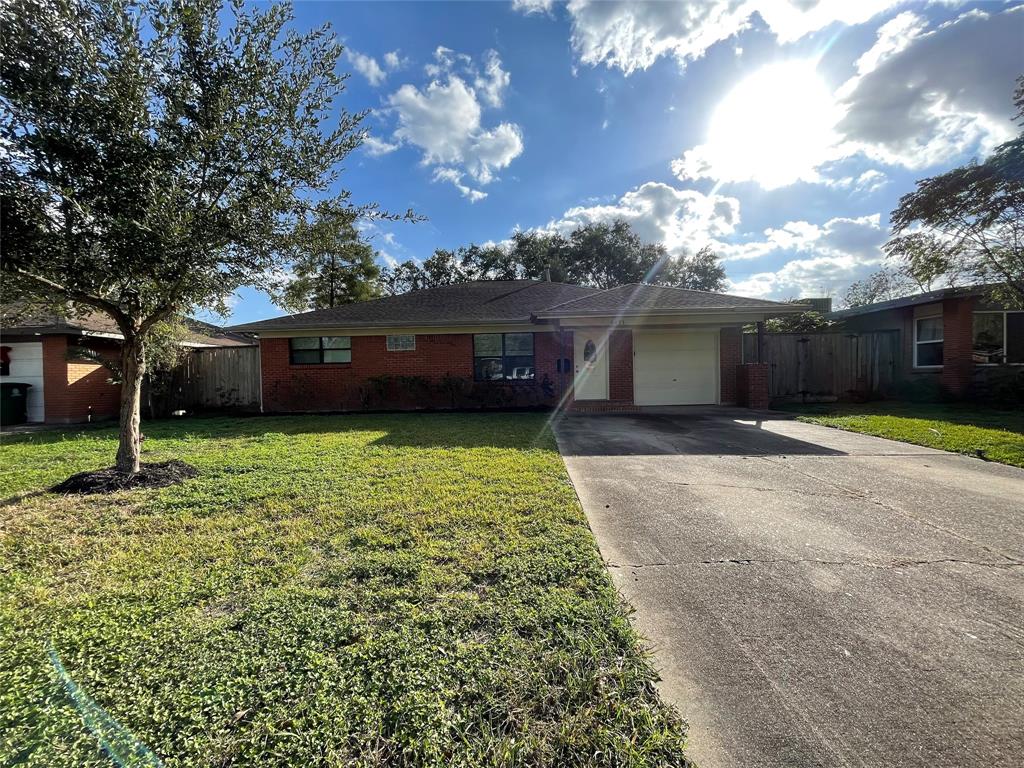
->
0;414;684;767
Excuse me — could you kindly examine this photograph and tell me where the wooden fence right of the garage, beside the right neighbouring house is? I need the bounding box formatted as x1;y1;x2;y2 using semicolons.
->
743;331;900;400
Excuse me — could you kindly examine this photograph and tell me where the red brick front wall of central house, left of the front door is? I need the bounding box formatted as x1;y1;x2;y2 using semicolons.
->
260;333;560;413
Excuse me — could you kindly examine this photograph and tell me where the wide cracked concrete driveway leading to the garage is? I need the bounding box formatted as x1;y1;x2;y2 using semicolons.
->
556;409;1024;768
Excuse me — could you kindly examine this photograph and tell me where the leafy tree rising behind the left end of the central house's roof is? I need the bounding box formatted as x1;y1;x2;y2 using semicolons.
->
271;210;380;312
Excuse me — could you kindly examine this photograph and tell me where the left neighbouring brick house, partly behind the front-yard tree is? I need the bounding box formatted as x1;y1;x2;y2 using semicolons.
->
0;308;253;424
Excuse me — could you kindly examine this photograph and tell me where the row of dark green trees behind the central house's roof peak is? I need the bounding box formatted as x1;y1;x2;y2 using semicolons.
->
382;220;725;294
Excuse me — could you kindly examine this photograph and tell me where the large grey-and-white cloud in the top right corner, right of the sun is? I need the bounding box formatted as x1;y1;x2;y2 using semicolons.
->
838;7;1024;169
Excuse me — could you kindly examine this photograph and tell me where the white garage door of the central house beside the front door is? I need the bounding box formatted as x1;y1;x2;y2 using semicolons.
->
633;329;719;406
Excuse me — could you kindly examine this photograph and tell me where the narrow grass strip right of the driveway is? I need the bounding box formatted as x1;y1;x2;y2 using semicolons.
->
785;401;1024;467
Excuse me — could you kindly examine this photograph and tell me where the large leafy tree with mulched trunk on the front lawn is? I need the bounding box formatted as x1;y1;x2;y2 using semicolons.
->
0;0;403;472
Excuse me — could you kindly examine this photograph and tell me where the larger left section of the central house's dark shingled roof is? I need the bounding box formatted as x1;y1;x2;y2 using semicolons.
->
230;280;600;332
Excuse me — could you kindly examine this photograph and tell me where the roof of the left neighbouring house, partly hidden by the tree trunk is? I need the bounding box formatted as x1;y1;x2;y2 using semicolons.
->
0;304;256;347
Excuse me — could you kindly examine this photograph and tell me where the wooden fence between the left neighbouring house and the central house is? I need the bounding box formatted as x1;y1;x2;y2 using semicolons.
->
154;346;259;413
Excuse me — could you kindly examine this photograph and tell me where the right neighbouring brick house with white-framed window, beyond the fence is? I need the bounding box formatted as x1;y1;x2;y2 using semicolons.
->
826;286;1024;397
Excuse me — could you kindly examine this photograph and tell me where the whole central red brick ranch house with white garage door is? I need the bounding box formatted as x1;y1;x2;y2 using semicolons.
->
228;280;803;413
